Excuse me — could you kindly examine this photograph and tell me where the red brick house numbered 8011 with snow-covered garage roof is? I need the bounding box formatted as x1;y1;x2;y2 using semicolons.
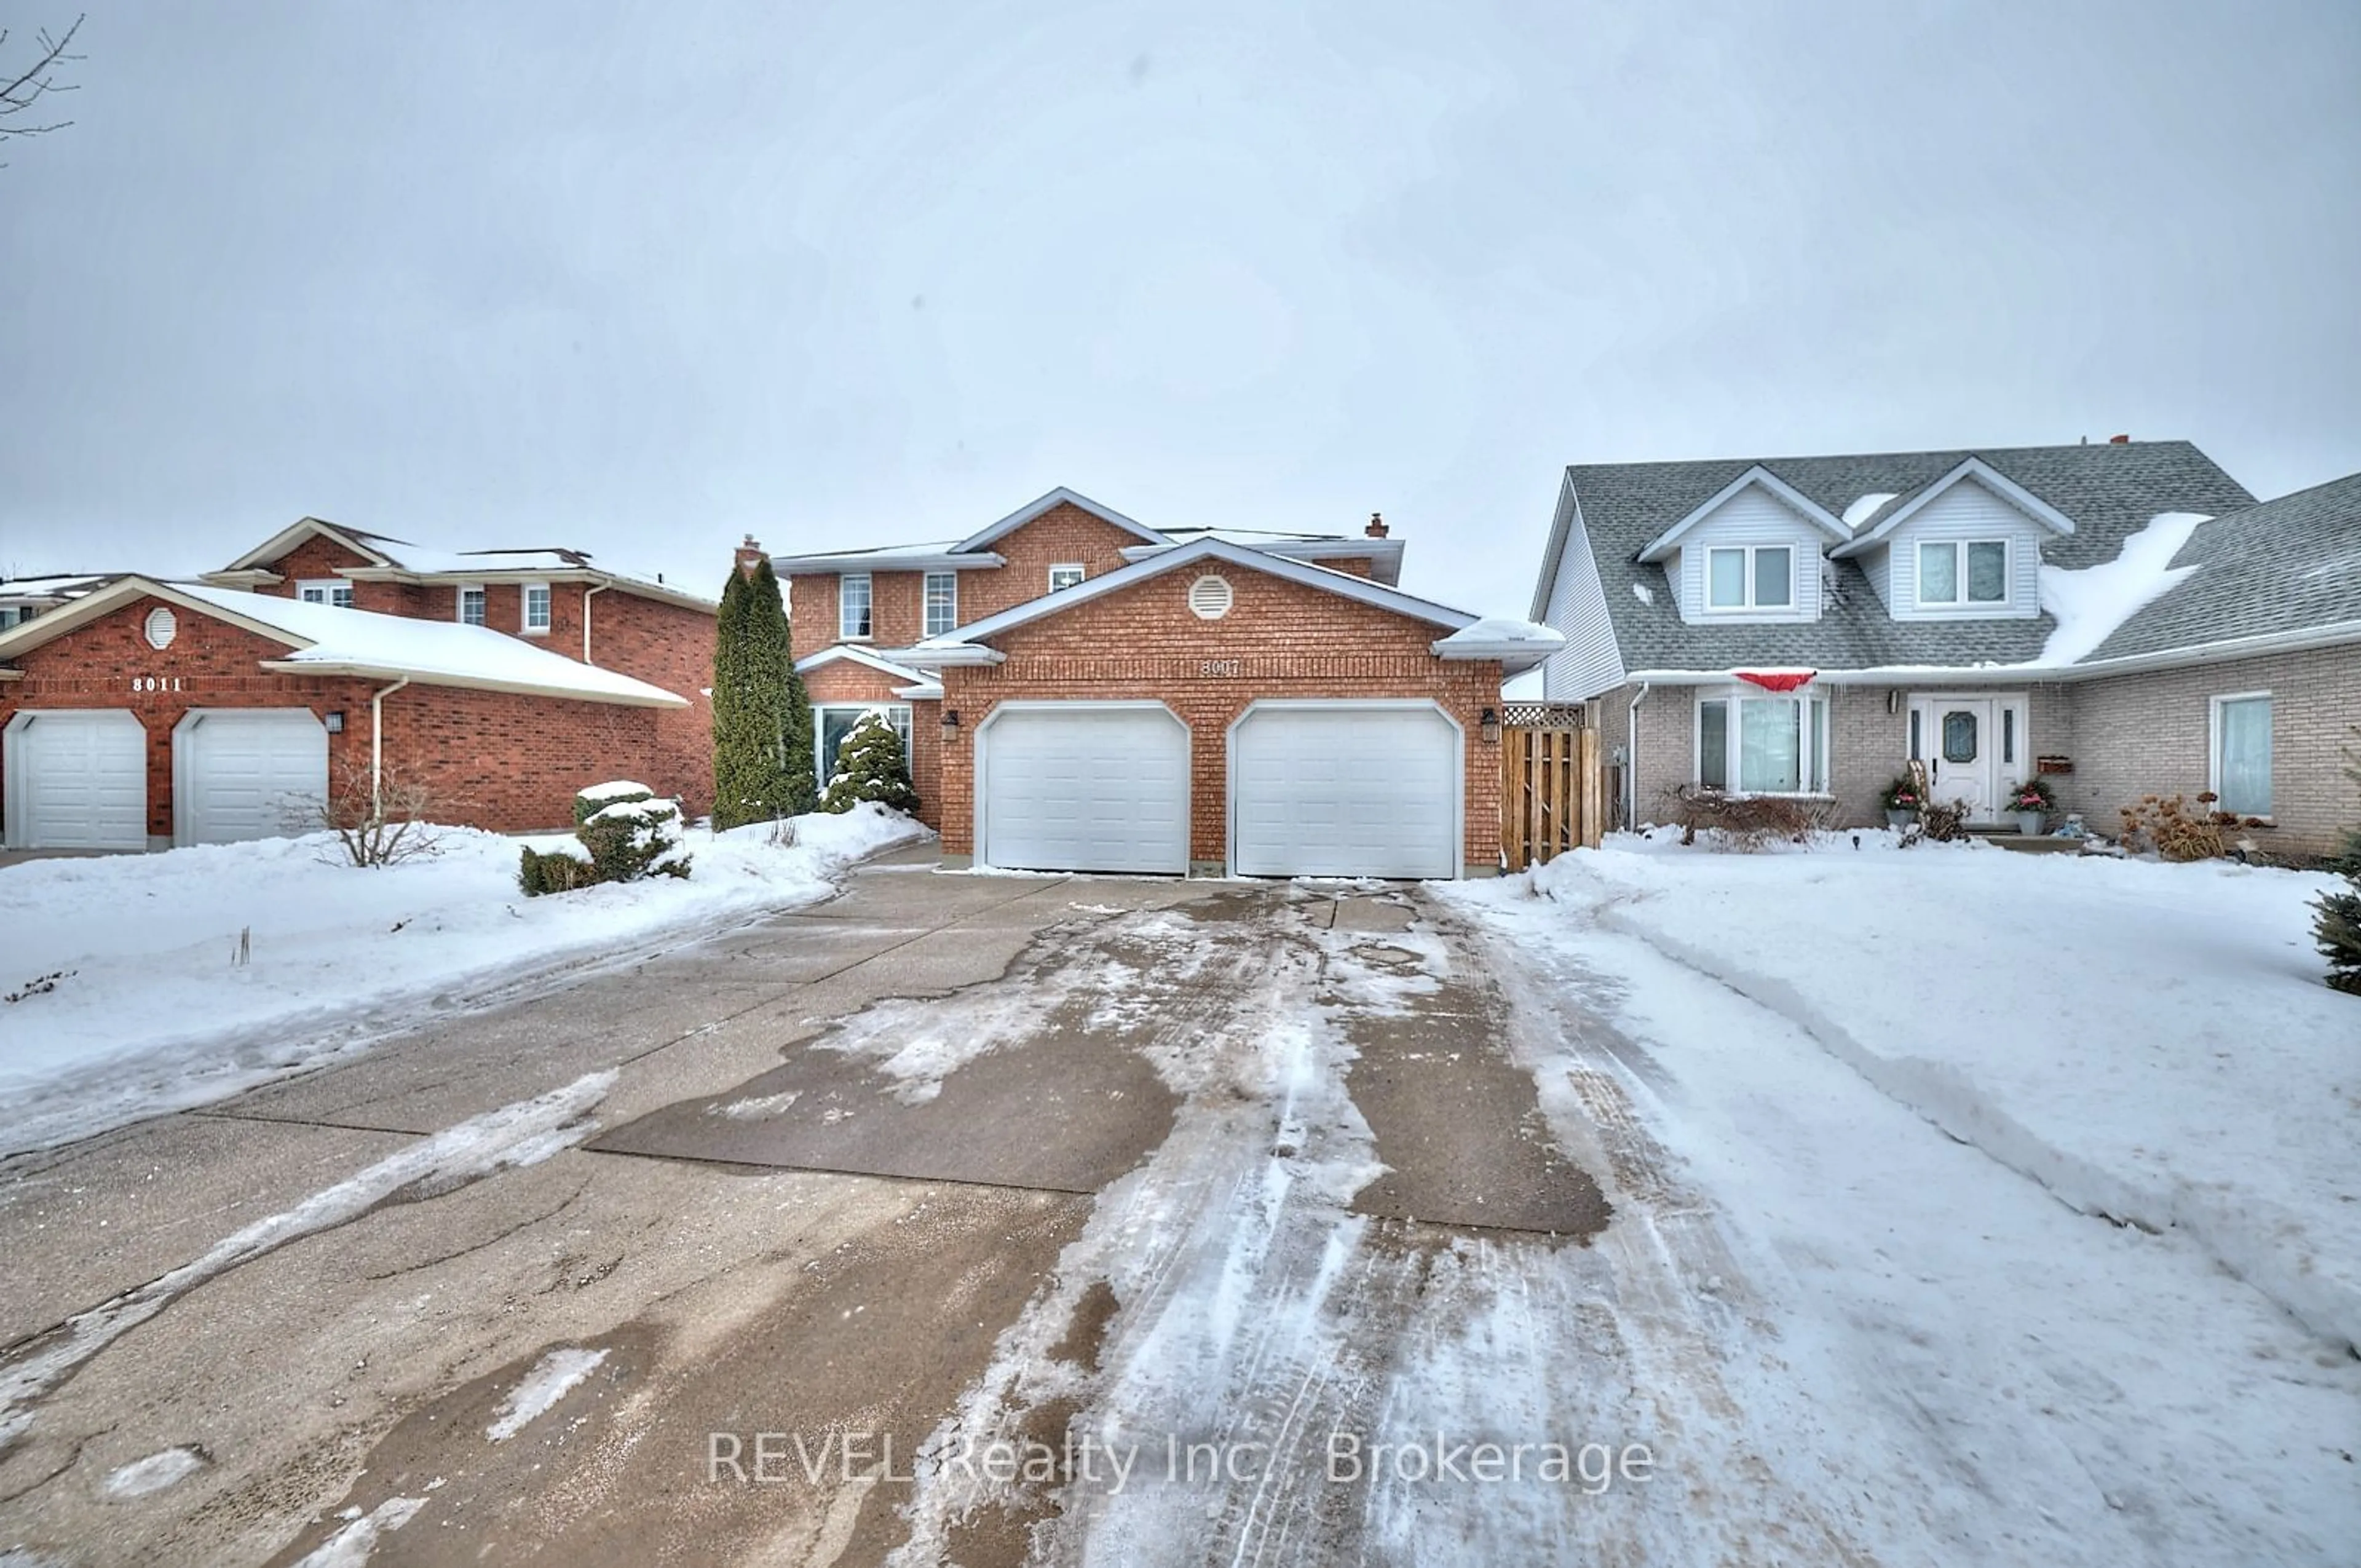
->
0;517;713;848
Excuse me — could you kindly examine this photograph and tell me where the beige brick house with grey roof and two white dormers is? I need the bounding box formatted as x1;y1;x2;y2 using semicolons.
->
1532;441;2361;857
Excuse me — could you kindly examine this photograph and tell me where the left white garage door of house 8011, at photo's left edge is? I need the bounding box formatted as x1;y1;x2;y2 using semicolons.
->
0;708;146;850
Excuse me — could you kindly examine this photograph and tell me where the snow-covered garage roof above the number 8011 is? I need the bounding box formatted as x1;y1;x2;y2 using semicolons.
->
0;576;689;708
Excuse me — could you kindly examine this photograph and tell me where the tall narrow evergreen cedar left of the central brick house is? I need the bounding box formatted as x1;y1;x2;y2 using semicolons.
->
713;560;819;829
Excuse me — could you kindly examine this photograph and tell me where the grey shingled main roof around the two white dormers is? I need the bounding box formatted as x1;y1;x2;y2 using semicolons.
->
1544;441;2255;671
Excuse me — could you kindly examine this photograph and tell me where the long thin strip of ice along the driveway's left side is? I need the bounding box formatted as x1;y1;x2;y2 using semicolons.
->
0;1070;616;1454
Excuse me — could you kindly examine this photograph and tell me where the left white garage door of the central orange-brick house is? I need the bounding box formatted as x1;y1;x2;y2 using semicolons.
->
978;703;1188;874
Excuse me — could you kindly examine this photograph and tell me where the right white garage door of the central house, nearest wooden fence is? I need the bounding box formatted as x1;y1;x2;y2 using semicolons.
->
1230;702;1459;876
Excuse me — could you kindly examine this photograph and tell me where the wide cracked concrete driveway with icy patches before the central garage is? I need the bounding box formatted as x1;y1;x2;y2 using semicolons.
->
0;855;1631;1568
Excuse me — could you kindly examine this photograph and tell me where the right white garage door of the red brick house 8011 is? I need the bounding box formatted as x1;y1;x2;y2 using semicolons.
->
172;708;328;843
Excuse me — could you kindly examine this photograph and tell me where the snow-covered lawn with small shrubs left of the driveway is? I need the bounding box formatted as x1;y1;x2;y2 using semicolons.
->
0;806;923;1152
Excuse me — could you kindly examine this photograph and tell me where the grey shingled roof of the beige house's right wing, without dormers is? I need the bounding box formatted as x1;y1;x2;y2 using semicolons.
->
2085;475;2361;663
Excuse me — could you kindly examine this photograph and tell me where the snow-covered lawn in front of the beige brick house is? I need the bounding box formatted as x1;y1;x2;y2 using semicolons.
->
1445;829;2361;1344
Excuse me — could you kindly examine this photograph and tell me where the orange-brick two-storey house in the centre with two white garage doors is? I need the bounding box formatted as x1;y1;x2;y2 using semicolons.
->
775;489;1558;876
